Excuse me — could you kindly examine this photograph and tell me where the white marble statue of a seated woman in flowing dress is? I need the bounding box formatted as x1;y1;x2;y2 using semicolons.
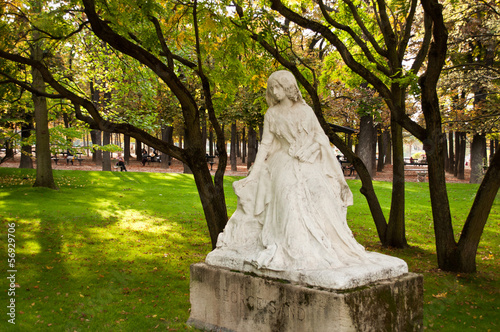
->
206;71;408;288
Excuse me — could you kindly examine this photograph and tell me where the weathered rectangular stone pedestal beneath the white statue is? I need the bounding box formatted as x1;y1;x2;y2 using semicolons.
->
188;263;423;332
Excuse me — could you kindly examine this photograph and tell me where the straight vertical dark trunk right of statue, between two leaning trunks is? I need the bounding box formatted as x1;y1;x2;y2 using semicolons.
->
386;119;408;248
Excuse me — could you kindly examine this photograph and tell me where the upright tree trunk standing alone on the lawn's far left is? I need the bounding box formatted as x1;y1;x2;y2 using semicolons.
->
31;30;57;189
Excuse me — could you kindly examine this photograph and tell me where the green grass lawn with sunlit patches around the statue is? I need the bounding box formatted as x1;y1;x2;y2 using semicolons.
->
0;168;500;331
